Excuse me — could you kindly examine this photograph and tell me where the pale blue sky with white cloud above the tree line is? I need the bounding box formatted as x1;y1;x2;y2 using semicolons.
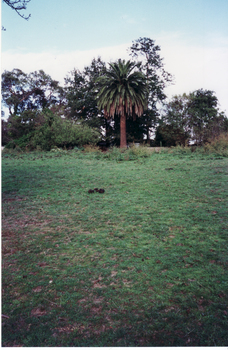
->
1;0;228;116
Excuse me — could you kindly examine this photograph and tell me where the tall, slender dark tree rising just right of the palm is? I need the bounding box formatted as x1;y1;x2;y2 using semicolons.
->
129;37;172;143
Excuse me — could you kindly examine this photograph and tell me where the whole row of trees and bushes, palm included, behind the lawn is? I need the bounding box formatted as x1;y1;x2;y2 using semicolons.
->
2;38;228;150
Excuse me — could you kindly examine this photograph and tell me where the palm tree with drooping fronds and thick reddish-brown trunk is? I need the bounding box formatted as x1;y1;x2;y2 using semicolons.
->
97;59;147;148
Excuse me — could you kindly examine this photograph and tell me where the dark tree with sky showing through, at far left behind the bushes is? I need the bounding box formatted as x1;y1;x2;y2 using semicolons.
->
2;69;65;143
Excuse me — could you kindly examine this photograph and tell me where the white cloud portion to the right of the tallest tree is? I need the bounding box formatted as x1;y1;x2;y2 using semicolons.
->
158;34;228;115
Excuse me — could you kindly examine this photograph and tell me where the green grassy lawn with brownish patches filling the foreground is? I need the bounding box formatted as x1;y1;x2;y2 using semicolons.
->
2;151;228;347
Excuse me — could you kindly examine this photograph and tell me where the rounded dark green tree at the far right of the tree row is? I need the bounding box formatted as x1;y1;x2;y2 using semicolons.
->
155;89;227;146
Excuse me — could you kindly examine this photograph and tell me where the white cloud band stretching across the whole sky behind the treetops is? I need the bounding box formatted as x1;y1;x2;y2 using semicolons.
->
2;33;228;114
